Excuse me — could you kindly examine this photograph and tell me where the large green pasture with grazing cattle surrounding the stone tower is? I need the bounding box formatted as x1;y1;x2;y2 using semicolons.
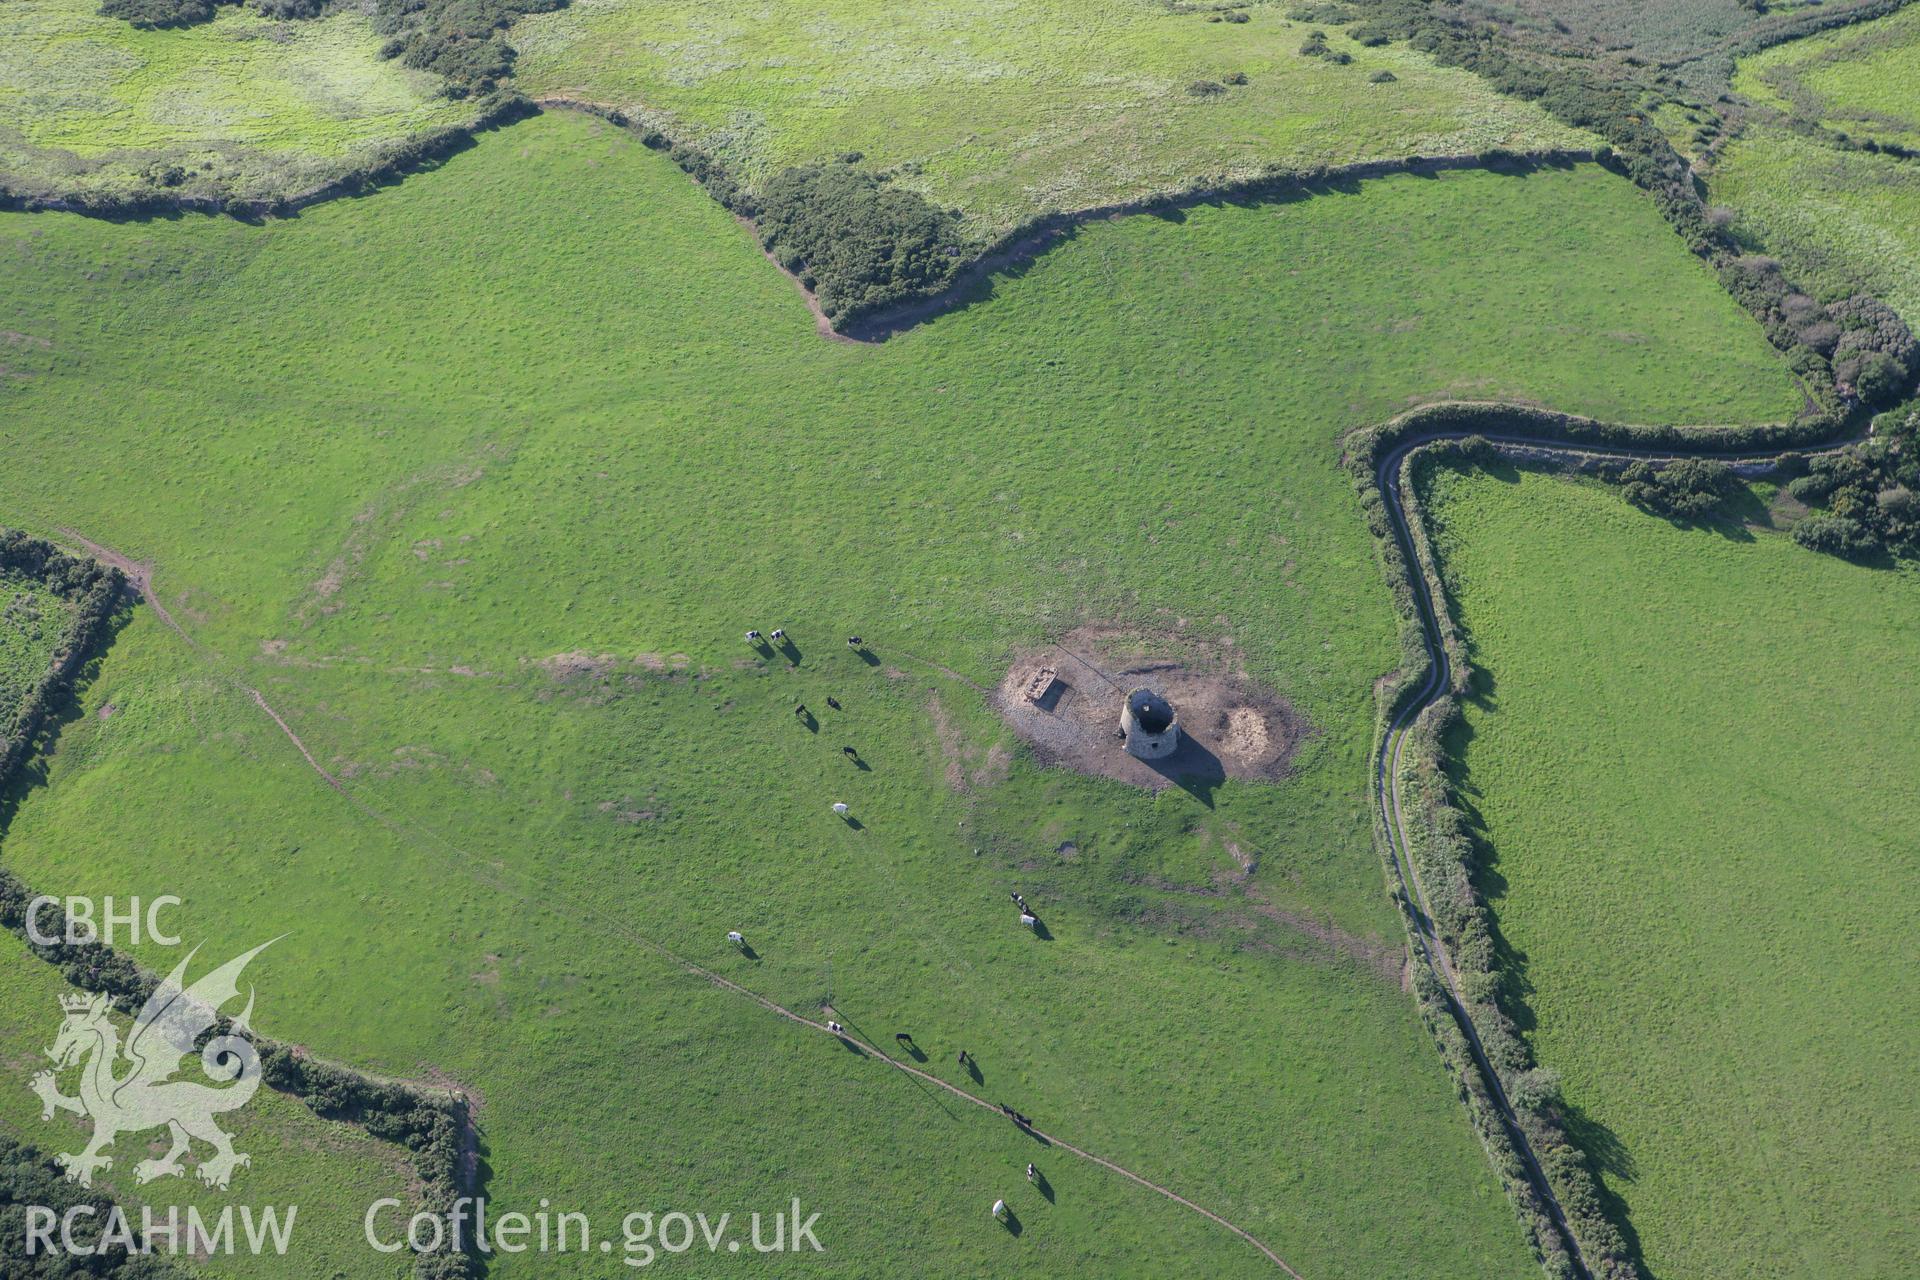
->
0;115;1797;1280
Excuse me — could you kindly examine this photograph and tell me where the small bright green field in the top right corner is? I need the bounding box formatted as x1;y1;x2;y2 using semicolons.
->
1734;8;1920;146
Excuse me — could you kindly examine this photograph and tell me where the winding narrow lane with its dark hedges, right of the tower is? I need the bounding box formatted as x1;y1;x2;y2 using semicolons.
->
1344;403;1860;1280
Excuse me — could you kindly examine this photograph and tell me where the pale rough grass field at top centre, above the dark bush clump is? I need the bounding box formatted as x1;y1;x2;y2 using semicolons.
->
513;0;1589;242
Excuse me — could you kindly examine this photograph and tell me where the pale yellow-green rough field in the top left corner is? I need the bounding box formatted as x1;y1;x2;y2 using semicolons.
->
0;0;472;198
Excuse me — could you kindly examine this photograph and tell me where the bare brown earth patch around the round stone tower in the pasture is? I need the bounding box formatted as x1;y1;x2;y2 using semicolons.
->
989;626;1311;791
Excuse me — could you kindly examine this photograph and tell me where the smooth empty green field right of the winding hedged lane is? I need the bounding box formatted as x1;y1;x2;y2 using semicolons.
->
1434;472;1920;1280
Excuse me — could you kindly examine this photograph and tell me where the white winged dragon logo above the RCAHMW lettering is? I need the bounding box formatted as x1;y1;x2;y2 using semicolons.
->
33;938;278;1190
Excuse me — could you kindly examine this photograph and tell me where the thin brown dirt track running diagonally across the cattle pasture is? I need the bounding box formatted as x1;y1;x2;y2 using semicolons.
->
56;526;1304;1280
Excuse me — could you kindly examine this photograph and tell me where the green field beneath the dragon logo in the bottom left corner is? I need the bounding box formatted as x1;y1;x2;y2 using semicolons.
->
0;933;413;1280
